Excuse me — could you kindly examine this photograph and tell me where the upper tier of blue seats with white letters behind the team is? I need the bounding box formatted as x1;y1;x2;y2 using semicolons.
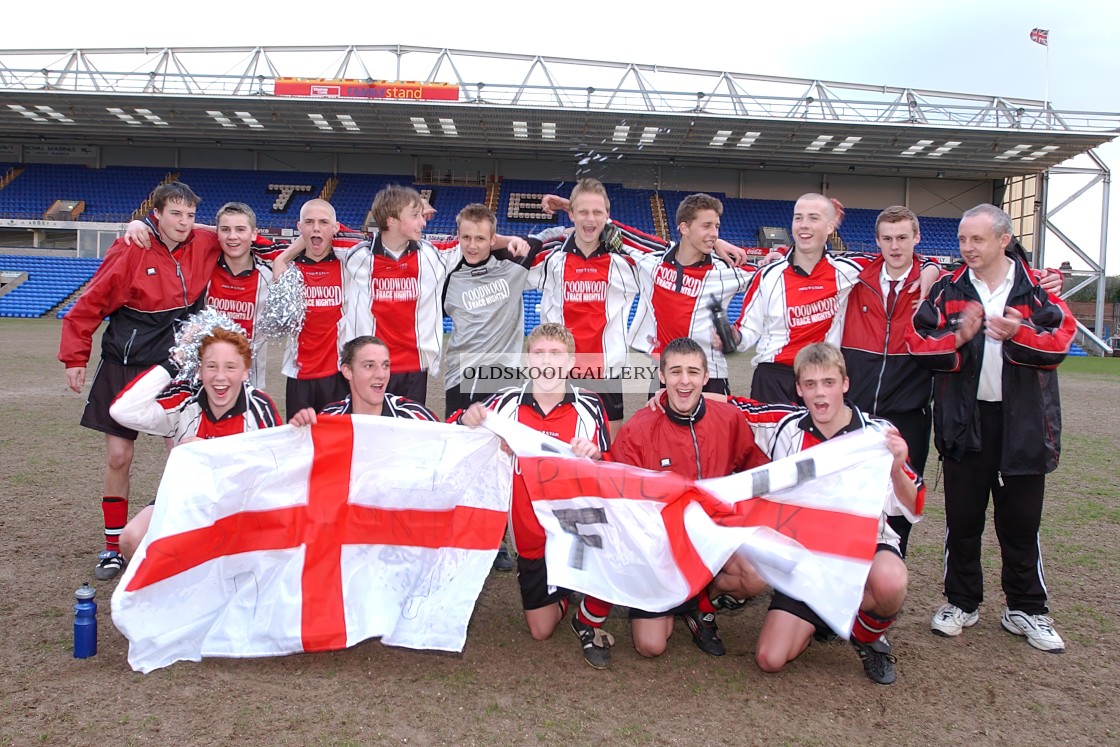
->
0;164;960;254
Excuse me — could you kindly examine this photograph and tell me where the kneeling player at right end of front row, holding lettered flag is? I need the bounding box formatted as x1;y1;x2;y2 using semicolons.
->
755;343;925;684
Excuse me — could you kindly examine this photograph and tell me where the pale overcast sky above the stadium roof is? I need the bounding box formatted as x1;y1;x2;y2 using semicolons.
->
2;0;1120;274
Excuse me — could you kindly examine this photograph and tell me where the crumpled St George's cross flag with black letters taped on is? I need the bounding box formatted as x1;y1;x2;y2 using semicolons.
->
485;418;893;637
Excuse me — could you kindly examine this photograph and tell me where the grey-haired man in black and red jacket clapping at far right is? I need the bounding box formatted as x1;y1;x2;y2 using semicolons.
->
907;205;1075;653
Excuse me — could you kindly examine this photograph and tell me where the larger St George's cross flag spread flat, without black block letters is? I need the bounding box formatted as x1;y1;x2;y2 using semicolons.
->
112;415;512;672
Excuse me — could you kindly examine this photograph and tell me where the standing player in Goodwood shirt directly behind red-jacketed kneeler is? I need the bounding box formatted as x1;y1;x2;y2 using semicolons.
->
626;194;754;394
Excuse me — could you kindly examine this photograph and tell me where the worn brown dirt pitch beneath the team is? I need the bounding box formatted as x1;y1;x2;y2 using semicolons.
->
0;319;1120;745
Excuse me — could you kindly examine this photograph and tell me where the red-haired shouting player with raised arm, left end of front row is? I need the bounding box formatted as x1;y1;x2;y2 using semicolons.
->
110;327;280;558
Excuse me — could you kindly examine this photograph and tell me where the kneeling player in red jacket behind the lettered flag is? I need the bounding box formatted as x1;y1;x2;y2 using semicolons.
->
610;337;768;656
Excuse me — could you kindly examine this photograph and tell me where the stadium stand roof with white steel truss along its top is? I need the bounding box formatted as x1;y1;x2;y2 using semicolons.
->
0;45;1120;179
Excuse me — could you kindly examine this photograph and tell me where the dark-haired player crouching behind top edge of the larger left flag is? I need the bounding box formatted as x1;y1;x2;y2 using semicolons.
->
289;336;439;426
